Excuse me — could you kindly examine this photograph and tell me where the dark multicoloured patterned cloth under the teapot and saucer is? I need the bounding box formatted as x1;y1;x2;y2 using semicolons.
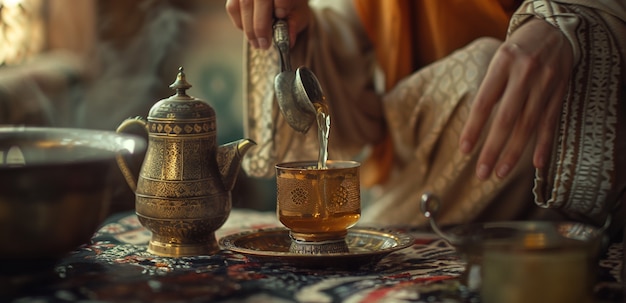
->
0;210;623;303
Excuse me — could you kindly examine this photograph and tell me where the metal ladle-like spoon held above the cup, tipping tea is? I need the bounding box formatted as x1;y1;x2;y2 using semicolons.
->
274;19;324;133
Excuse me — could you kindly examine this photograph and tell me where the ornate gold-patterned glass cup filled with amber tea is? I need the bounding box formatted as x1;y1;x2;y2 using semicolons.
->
276;160;361;254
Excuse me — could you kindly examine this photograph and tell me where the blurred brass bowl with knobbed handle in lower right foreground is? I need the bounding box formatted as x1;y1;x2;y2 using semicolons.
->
420;193;606;302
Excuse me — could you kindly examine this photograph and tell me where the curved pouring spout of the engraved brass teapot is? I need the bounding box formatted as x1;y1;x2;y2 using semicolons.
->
217;139;256;191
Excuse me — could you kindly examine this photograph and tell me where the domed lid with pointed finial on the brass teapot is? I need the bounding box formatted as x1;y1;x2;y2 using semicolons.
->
148;67;215;120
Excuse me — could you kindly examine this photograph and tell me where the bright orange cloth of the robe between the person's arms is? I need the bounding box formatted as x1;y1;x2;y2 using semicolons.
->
354;0;519;89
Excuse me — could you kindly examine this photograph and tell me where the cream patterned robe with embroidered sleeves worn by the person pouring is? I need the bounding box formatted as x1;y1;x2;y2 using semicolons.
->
243;0;626;225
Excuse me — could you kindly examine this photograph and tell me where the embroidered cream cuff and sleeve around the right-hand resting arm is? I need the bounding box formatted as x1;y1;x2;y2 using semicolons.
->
509;1;625;223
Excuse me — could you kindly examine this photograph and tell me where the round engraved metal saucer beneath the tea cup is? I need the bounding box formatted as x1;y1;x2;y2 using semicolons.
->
219;227;414;269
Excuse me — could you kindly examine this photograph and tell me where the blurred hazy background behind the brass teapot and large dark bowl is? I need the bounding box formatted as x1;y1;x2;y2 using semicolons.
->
0;0;276;212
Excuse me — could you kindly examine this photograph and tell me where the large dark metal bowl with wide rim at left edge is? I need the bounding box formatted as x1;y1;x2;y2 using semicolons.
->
0;126;146;268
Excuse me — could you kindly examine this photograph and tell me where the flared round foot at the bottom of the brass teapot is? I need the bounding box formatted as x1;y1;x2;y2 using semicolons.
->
148;237;220;257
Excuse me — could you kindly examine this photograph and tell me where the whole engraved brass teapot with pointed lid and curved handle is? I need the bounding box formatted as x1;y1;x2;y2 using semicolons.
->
117;67;255;257
